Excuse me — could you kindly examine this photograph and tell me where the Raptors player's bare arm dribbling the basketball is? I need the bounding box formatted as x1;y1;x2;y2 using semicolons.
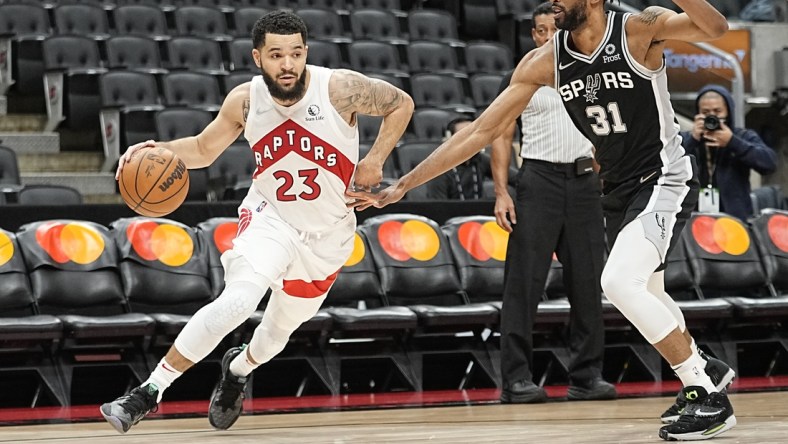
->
115;83;249;180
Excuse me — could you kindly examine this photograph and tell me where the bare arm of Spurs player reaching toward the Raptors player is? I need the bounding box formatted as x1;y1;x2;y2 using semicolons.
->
348;45;555;210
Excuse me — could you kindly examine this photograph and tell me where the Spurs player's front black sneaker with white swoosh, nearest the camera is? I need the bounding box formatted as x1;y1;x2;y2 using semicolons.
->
659;386;736;441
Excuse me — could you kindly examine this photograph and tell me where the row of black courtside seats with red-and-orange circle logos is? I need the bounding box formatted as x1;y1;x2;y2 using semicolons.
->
0;211;788;404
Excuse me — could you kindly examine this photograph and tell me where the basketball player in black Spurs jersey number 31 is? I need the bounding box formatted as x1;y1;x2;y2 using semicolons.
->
348;0;736;440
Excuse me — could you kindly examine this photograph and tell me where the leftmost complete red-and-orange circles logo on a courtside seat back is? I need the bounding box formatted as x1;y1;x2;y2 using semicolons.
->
34;222;104;265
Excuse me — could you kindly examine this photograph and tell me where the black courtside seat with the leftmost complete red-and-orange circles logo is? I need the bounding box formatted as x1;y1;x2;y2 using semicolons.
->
17;220;156;404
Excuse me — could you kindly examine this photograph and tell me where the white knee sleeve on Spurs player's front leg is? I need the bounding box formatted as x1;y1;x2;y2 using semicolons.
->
602;220;678;344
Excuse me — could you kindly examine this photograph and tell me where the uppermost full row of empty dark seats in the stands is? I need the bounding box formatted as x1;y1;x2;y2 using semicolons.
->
0;4;462;45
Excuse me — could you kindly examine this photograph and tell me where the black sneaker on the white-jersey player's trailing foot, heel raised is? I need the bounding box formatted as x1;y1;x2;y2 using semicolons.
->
208;345;248;430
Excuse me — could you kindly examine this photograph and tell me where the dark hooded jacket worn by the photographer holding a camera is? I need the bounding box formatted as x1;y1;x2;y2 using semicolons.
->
681;85;777;221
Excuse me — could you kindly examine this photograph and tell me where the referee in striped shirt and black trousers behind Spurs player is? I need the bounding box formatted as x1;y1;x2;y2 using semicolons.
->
492;2;616;403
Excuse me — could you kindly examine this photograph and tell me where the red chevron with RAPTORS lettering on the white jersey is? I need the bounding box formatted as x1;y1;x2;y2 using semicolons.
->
252;120;355;185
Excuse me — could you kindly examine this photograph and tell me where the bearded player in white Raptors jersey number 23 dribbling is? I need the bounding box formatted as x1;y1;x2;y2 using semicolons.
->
101;11;413;433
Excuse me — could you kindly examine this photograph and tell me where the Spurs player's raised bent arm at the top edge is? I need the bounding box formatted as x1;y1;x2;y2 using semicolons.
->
635;0;728;42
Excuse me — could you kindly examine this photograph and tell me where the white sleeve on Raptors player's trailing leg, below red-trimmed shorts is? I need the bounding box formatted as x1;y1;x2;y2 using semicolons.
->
243;291;326;364
